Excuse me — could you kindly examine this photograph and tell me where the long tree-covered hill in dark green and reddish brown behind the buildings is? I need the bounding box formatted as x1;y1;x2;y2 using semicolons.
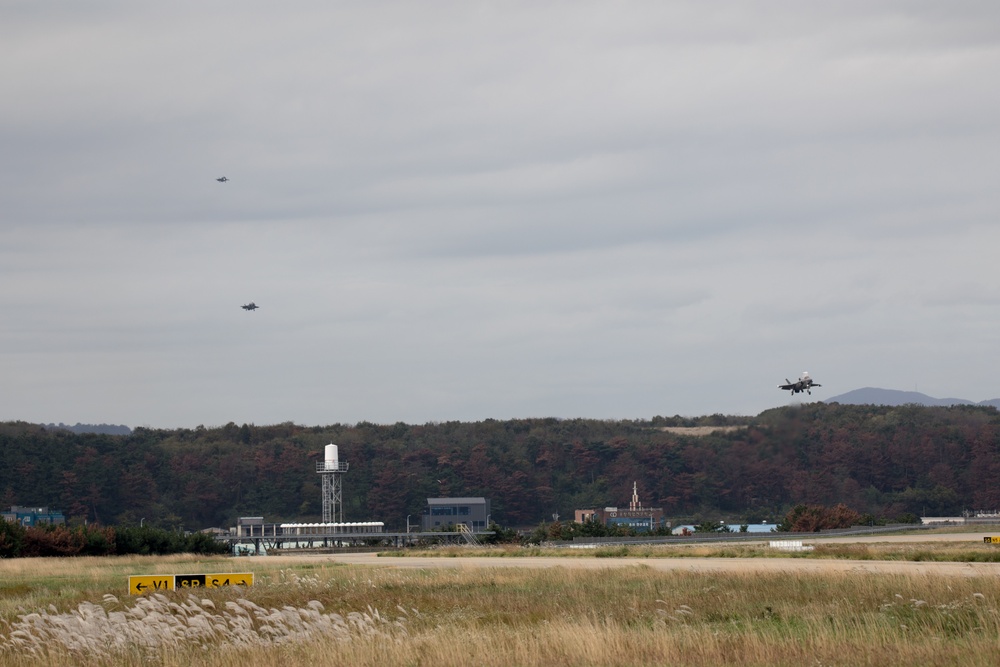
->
0;403;1000;529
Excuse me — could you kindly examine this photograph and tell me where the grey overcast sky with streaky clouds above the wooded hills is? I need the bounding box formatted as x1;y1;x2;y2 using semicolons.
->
0;0;1000;428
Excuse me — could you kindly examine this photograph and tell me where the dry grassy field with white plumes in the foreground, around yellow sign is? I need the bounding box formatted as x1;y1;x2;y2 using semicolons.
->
0;557;1000;667
